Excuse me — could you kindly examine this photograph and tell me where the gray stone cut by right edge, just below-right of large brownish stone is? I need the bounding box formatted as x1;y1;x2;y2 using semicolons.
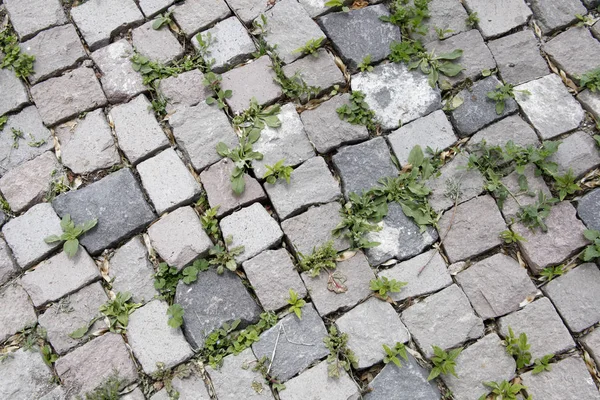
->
543;263;600;332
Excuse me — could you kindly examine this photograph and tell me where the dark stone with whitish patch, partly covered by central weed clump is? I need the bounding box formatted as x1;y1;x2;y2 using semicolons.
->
366;203;438;266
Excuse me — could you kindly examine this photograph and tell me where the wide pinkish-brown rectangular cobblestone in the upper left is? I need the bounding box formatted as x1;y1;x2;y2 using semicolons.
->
31;67;106;126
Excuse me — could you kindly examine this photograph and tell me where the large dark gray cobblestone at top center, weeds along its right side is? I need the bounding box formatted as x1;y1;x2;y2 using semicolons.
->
318;4;401;70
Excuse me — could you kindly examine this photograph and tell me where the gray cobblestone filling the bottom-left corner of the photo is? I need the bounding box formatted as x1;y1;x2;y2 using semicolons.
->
0;348;56;399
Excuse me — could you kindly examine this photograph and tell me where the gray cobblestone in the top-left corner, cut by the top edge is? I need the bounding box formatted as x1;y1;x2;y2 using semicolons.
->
4;0;67;40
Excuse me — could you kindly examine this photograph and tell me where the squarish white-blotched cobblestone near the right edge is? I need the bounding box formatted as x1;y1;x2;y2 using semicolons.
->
515;74;584;140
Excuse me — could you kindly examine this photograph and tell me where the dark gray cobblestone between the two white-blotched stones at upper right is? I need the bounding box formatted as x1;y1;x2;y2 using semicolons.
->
450;76;517;137
